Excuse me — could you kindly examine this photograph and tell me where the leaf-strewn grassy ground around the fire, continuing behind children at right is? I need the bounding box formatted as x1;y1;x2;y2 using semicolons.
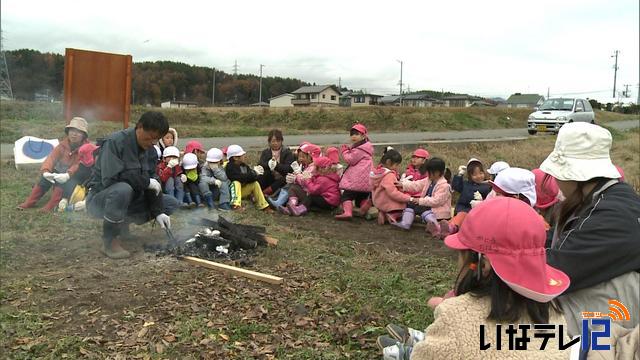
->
0;129;640;359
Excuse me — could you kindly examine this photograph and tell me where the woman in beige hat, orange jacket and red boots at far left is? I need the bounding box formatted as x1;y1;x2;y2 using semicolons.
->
18;117;89;211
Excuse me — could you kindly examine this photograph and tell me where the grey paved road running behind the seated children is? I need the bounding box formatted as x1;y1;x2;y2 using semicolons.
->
0;120;640;158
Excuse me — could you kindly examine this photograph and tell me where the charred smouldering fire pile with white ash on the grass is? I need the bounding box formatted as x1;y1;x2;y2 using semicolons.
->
144;216;271;265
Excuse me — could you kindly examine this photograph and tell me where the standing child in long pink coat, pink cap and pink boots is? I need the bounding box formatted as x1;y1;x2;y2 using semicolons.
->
335;123;373;220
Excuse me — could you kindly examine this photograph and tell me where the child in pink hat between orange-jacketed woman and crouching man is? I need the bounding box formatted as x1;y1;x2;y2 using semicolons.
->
58;143;98;212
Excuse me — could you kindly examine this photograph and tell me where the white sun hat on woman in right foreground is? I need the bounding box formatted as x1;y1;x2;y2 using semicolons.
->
540;122;620;181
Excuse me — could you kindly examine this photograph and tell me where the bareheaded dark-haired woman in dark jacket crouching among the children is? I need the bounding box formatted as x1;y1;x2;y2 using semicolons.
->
258;129;295;196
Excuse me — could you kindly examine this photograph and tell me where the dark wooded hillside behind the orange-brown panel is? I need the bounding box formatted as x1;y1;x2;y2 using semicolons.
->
6;49;309;106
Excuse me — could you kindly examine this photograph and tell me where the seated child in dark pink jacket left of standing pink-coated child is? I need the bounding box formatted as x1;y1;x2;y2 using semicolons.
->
280;156;340;216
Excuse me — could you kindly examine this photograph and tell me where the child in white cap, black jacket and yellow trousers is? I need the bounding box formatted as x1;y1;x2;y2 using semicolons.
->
226;145;270;211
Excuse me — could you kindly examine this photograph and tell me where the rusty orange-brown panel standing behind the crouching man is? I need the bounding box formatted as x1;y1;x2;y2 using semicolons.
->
64;49;131;128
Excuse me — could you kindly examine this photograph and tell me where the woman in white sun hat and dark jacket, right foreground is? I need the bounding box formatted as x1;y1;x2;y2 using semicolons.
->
540;123;640;336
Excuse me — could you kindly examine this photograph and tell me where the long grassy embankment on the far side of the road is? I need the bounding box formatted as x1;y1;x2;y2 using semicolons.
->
0;101;637;142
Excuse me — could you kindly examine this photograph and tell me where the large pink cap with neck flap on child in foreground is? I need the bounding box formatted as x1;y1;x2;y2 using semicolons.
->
444;197;570;303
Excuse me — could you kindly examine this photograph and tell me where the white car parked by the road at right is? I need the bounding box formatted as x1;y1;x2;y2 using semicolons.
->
527;98;595;135
